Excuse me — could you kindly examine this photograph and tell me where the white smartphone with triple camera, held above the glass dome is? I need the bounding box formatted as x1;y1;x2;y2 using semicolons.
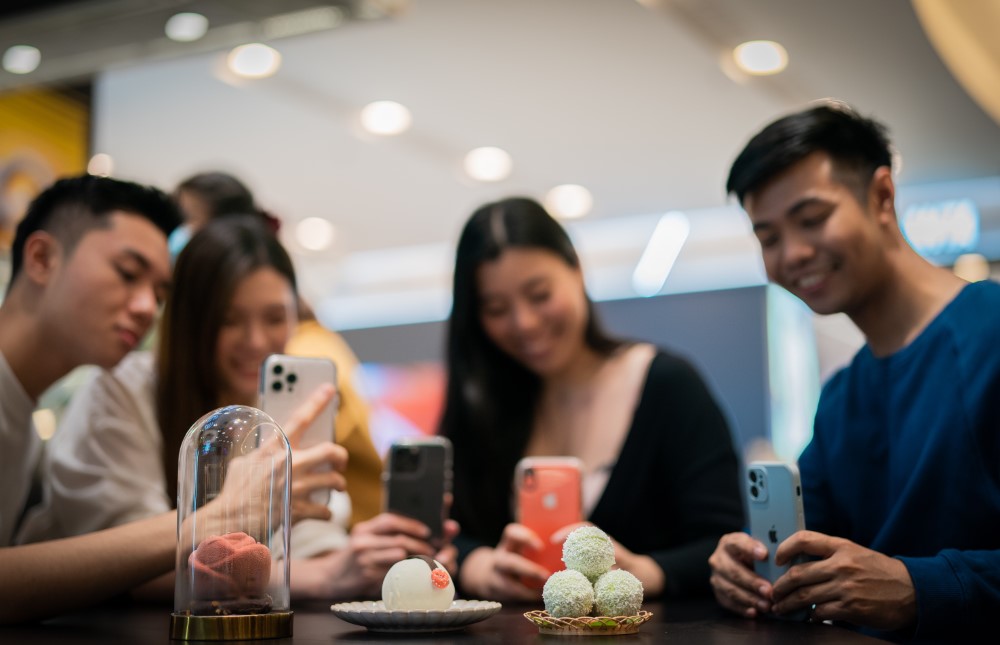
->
260;354;338;504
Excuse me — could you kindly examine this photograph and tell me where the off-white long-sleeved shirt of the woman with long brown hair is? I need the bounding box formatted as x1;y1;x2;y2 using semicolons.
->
17;352;350;557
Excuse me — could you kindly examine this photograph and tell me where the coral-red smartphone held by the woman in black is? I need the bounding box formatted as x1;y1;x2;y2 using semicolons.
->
514;457;583;571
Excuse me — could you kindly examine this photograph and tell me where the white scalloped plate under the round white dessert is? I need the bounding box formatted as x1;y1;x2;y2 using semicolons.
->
330;600;501;633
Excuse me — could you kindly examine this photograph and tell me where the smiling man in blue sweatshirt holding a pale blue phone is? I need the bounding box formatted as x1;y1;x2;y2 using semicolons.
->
709;103;1000;640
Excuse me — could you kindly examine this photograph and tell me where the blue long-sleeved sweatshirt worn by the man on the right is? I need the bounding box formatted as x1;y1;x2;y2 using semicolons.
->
799;282;1000;640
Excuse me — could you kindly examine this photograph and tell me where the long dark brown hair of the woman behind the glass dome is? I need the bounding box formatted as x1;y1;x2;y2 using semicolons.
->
156;215;295;499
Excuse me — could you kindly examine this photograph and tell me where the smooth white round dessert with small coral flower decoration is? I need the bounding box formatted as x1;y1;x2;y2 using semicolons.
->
382;556;455;611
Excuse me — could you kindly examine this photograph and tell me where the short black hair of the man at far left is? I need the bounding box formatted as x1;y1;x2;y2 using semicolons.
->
8;175;181;289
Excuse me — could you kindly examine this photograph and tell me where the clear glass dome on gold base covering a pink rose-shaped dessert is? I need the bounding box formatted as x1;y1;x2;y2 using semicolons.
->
171;405;292;640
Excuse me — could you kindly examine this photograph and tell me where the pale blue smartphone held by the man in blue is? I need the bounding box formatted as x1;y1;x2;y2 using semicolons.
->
746;461;807;620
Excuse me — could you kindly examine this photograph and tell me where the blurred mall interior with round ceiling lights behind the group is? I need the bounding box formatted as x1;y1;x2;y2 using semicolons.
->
0;0;1000;460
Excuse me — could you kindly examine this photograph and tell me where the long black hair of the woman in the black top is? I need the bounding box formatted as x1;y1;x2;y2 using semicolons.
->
440;197;622;543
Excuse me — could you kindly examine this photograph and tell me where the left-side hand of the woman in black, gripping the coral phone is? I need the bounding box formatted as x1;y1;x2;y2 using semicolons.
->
461;523;549;601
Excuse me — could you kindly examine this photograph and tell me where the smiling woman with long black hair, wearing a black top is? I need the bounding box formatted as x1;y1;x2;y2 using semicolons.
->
441;198;743;600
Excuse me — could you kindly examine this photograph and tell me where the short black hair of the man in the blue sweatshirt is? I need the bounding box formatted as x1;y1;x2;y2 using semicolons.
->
726;101;892;204
